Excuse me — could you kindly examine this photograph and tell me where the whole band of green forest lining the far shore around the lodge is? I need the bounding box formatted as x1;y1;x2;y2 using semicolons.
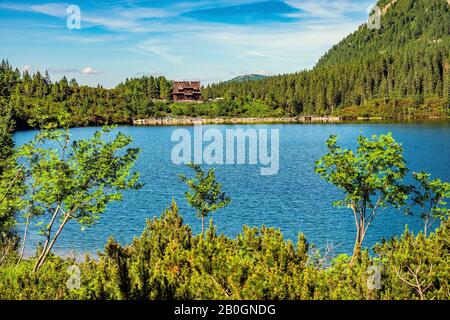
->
0;0;450;128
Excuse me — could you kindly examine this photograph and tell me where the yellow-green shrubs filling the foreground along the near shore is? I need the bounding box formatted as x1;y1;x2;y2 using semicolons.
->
0;203;450;300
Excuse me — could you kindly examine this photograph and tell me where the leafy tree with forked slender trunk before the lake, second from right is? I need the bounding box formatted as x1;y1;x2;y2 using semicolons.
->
315;134;410;265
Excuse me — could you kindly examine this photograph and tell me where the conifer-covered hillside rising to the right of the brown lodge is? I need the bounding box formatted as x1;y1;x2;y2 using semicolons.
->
204;0;450;117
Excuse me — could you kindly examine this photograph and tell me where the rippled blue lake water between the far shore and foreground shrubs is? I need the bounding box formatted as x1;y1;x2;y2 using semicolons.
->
15;121;450;254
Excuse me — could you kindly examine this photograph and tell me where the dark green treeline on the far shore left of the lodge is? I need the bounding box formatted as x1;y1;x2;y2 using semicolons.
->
0;61;172;127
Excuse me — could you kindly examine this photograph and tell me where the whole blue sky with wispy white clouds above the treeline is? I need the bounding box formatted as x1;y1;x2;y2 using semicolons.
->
0;0;374;87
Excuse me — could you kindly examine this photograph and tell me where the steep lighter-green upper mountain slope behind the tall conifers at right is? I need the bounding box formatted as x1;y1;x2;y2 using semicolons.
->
318;0;450;66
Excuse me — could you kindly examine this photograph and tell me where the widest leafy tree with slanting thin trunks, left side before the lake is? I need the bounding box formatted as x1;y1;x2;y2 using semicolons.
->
18;127;140;272
